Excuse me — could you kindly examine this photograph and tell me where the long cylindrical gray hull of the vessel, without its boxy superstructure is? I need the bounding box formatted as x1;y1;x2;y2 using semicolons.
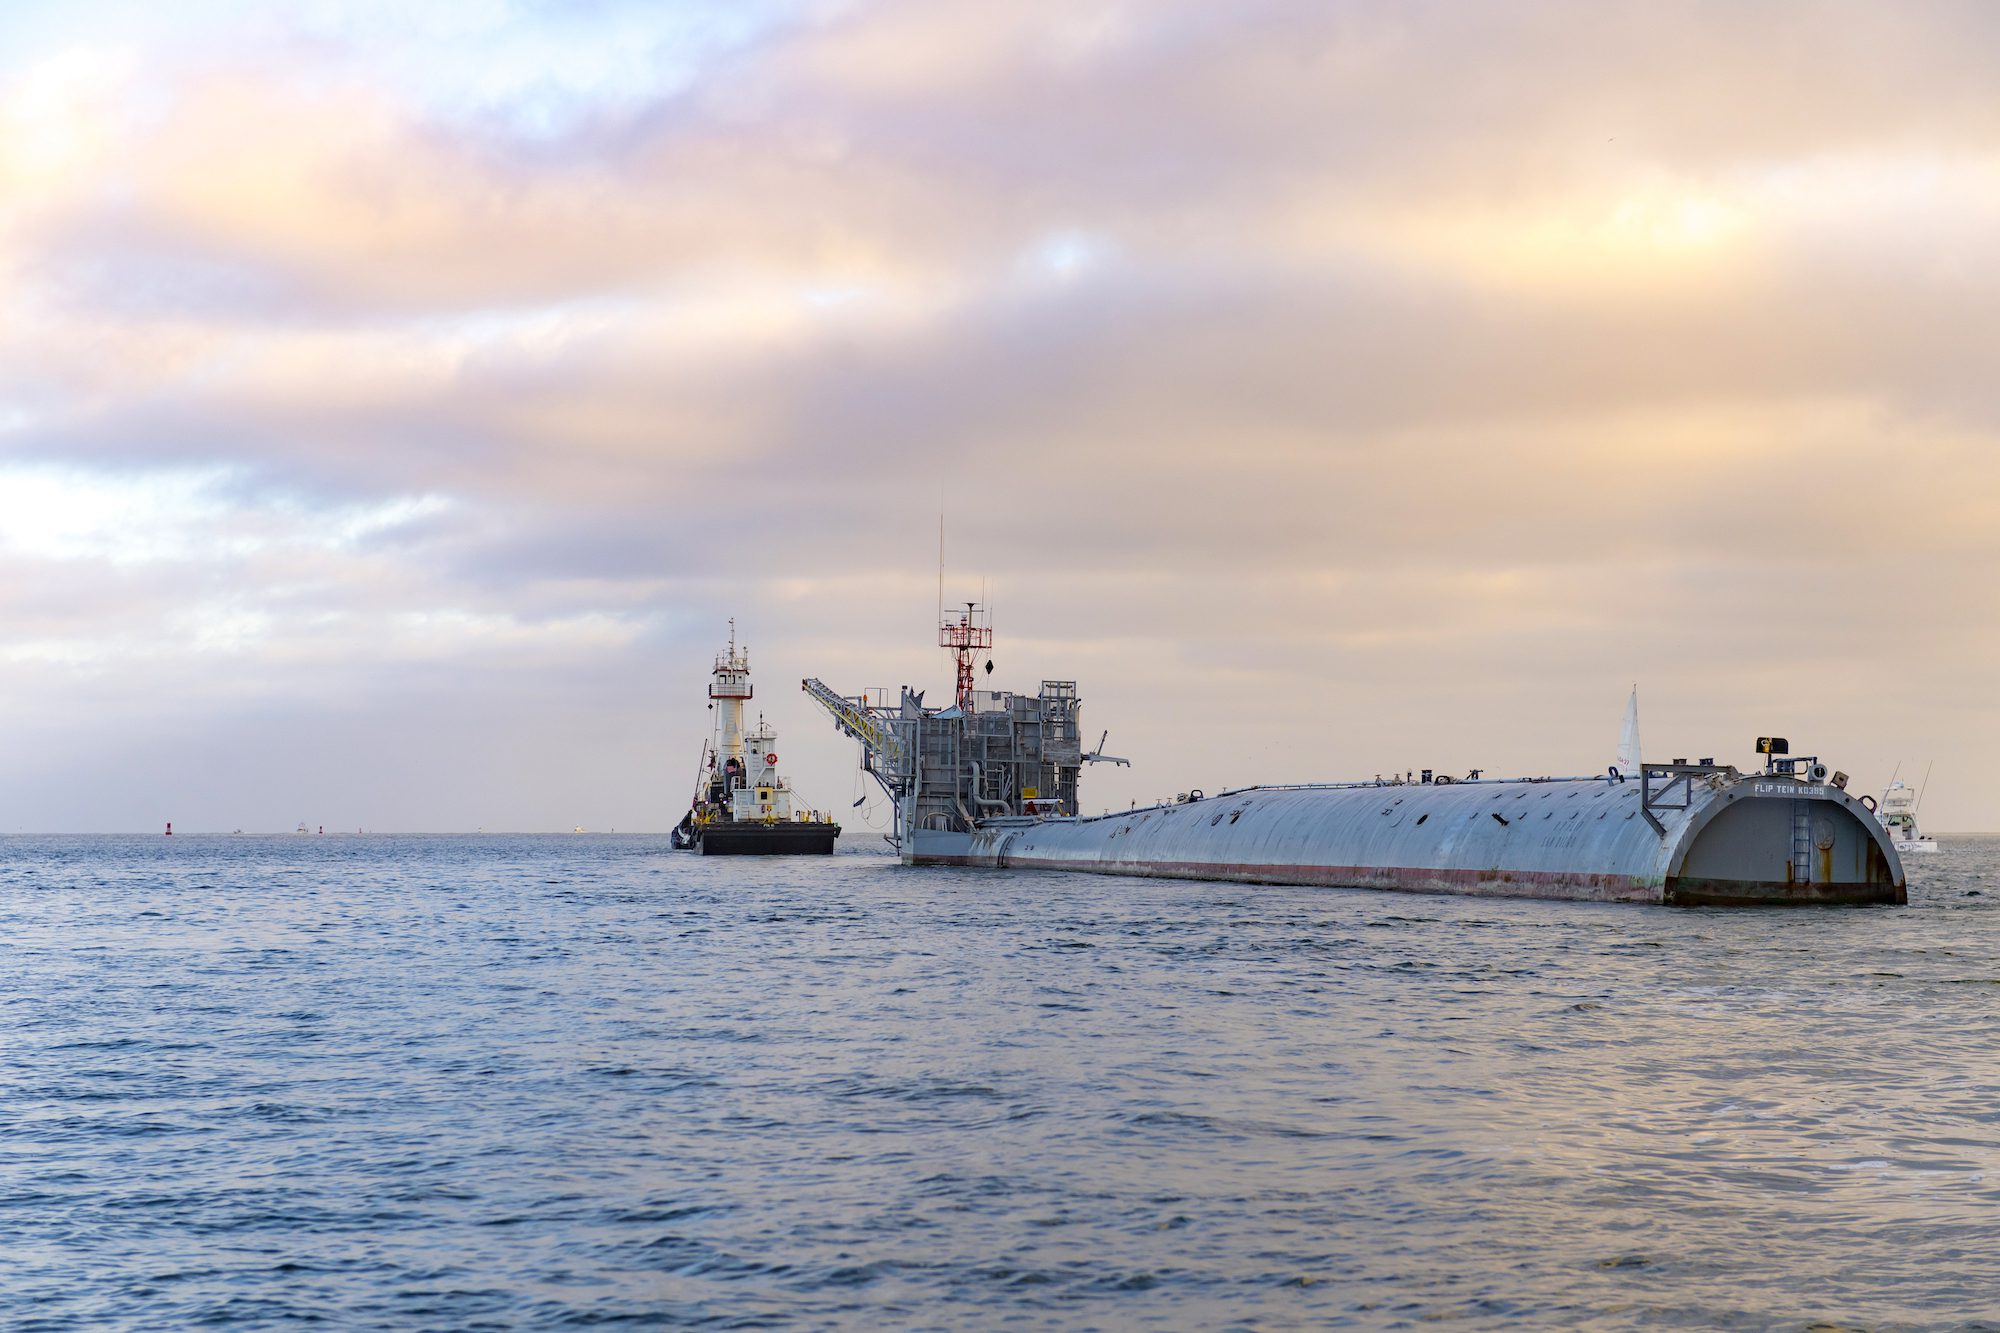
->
948;773;1904;905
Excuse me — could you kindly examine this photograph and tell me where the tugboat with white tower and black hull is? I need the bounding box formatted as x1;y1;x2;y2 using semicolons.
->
672;620;840;857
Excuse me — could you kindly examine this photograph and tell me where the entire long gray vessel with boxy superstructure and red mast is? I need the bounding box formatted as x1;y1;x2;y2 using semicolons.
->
802;604;1904;907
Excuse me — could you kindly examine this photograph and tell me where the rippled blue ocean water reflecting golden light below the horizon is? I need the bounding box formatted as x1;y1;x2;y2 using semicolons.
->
0;837;2000;1329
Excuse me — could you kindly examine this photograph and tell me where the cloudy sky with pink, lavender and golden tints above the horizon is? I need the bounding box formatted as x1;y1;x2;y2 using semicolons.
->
0;0;2000;831
